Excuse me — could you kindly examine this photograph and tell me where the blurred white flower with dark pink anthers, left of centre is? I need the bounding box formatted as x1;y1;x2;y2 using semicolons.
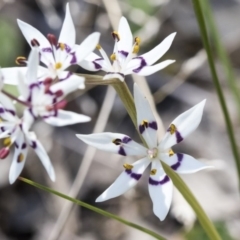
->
17;48;91;126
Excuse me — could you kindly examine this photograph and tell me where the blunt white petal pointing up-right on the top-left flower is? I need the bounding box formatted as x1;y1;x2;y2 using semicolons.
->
75;32;100;64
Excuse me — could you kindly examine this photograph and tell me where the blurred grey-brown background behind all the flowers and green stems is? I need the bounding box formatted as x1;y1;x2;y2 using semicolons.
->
0;0;240;240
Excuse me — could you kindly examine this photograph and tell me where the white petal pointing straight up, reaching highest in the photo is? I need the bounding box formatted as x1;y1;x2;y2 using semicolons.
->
58;3;76;48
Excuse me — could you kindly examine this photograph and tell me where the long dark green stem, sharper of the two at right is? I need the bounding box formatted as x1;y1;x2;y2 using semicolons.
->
192;0;240;188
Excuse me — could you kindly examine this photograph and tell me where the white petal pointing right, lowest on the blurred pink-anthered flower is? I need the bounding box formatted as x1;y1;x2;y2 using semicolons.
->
44;109;91;127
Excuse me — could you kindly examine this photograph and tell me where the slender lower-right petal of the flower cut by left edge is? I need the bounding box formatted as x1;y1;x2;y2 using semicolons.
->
28;132;55;182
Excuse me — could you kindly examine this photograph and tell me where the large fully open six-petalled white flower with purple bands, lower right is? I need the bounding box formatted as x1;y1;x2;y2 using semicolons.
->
77;84;209;220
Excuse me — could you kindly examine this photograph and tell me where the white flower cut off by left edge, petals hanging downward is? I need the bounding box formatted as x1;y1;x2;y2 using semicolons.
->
0;92;55;184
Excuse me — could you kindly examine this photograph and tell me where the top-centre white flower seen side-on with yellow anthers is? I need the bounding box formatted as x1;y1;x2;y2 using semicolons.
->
79;17;176;81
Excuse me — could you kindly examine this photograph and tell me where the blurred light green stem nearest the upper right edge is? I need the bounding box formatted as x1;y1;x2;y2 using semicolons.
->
200;0;240;119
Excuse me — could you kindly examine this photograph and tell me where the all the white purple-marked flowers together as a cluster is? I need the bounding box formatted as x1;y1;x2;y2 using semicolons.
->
0;4;208;220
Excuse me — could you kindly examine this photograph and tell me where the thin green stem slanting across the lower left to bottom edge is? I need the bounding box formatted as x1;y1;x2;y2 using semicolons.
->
19;177;165;240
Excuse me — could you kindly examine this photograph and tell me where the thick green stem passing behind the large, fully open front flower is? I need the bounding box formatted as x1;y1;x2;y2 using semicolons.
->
115;77;221;240
